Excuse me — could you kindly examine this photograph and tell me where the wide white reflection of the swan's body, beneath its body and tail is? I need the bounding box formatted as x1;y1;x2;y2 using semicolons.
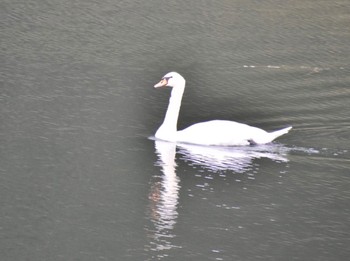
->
178;141;289;173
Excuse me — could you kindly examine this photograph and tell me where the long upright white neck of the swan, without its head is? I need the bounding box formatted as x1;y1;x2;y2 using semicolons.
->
155;81;185;141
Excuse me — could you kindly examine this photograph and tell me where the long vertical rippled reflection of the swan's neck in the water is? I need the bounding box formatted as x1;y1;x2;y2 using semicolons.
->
149;141;180;251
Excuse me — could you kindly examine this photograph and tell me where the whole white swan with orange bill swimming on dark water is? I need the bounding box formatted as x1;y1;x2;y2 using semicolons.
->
154;72;292;146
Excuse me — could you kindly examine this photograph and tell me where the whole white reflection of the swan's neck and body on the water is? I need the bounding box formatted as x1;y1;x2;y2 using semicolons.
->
148;140;289;259
